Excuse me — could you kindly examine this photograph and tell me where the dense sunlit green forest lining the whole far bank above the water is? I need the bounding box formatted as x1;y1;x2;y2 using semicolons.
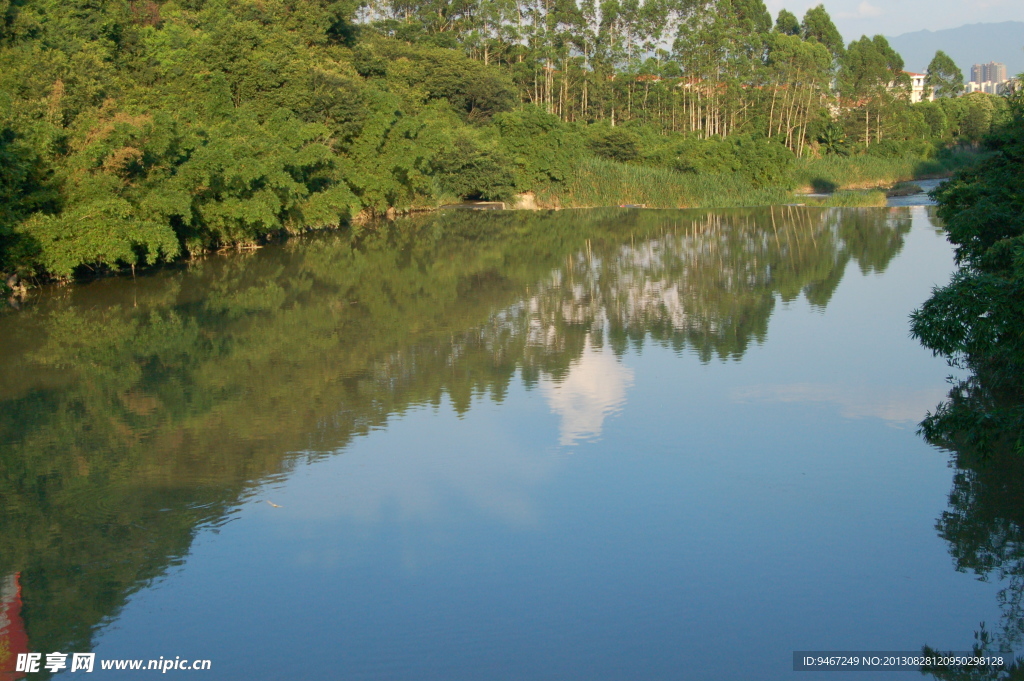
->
0;0;1005;282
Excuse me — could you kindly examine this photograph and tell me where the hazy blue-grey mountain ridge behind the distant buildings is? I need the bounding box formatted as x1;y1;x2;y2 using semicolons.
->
889;22;1024;82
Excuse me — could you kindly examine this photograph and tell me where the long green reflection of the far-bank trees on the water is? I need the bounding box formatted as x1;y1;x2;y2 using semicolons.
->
0;208;908;667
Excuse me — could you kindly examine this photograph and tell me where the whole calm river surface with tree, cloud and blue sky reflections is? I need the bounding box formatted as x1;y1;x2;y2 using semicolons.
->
0;207;1024;681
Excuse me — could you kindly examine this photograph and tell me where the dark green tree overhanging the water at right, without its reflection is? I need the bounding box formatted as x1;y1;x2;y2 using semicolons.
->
911;91;1024;456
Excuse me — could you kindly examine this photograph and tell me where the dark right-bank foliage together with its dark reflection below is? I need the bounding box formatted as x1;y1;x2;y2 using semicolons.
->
911;106;1024;663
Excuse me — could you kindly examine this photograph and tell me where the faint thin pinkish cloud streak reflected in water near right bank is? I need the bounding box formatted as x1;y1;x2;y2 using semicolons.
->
732;383;946;425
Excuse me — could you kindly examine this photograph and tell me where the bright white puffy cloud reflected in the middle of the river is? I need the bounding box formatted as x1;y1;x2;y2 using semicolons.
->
541;340;633;445
